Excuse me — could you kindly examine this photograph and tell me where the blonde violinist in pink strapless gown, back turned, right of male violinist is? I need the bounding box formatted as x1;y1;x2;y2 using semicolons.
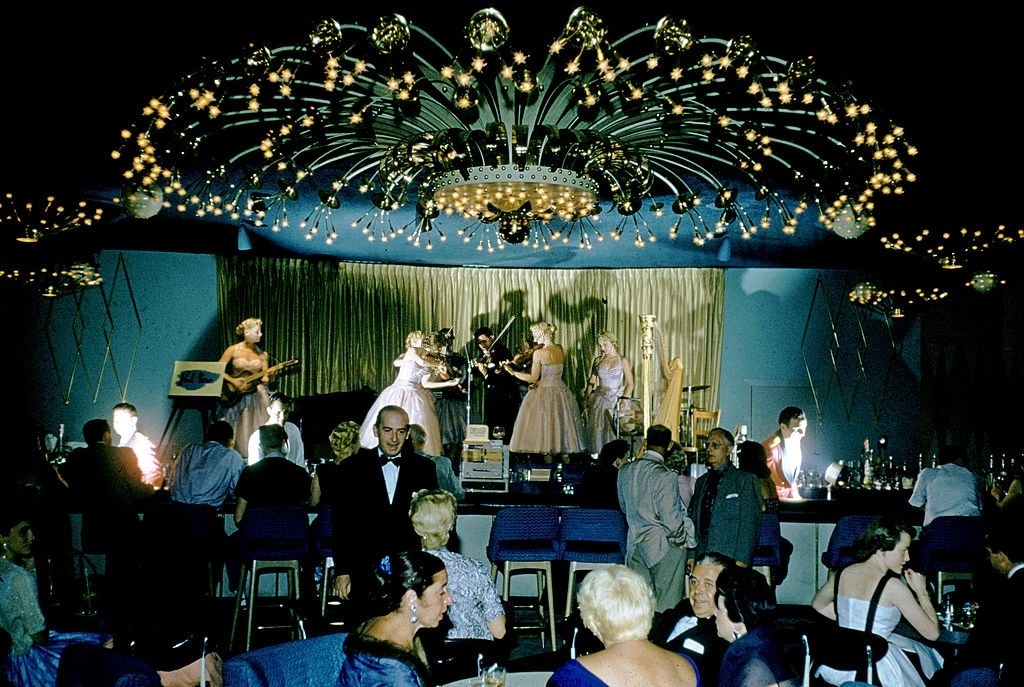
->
502;323;583;454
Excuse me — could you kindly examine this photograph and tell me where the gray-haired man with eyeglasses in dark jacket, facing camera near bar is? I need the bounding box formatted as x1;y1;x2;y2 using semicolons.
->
686;427;761;570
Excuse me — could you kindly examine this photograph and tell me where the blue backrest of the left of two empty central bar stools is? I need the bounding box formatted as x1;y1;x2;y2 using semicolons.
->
486;506;558;563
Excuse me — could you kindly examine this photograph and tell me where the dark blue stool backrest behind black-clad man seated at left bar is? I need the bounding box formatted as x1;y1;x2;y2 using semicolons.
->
239;506;312;561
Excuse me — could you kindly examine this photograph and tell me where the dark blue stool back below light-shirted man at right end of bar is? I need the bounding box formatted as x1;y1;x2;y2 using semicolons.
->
915;515;987;574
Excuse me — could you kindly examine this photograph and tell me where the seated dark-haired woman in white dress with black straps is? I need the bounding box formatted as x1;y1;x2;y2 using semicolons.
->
811;517;942;687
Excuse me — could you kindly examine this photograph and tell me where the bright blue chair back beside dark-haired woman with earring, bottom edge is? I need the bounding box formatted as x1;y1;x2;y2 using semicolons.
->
222;632;348;687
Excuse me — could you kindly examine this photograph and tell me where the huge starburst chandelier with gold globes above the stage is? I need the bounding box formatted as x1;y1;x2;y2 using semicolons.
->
114;7;915;251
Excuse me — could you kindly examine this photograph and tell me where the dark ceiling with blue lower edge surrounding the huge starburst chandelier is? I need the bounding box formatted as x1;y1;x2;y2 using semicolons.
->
0;1;1024;276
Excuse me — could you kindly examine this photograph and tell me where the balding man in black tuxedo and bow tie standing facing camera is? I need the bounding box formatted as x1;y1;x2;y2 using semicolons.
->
334;405;437;614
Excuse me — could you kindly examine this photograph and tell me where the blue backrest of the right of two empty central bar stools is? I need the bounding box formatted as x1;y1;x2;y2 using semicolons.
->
558;508;627;563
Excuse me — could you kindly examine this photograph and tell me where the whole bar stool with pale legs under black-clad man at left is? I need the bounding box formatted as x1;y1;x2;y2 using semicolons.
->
228;506;312;651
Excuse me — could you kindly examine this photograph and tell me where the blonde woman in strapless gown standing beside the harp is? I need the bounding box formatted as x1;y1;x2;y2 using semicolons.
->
585;332;633;455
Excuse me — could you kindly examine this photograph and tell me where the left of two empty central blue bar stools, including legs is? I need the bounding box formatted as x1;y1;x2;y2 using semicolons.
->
486;506;558;649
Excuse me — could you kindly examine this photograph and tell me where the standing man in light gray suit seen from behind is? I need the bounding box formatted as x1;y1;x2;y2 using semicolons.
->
616;425;694;613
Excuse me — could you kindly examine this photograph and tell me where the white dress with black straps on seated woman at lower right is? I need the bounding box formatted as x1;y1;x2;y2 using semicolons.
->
817;595;942;687
